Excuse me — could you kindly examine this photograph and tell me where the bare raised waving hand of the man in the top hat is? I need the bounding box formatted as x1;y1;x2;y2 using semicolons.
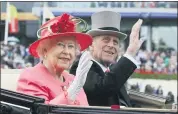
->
126;19;145;57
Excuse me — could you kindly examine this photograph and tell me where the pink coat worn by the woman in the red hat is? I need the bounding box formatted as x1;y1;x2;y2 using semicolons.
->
17;63;88;106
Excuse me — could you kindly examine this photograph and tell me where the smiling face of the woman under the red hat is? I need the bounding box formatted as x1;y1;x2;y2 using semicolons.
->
46;36;77;69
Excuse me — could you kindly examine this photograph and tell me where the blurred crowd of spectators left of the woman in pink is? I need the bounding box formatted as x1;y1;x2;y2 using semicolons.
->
1;42;34;69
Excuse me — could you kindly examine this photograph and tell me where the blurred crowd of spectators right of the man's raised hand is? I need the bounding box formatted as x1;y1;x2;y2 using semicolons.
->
136;50;178;74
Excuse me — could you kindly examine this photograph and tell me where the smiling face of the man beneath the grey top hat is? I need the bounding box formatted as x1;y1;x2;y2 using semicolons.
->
91;35;119;65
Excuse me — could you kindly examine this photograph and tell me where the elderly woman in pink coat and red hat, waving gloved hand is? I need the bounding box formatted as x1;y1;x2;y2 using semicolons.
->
17;13;92;105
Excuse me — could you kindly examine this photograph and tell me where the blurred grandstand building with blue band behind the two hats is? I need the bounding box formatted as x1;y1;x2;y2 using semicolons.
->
0;2;177;51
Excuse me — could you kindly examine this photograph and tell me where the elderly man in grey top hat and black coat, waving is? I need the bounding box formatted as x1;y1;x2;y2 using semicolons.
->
70;11;144;106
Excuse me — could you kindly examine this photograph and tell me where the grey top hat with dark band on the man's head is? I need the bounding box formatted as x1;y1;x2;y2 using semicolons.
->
87;11;127;40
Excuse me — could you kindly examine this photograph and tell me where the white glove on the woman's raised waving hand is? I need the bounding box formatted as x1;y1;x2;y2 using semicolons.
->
67;51;93;101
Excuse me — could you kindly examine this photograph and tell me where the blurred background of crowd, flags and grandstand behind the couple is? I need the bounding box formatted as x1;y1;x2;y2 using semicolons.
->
0;1;178;107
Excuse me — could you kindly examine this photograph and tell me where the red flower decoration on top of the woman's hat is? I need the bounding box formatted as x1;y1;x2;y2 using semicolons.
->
50;13;75;33
